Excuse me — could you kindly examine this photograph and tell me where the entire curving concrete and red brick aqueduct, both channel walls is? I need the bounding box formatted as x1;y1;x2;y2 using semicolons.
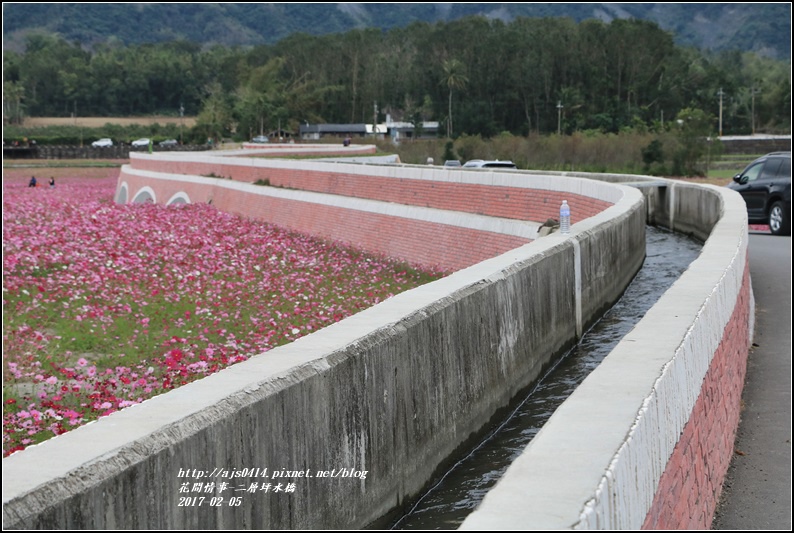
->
3;145;754;529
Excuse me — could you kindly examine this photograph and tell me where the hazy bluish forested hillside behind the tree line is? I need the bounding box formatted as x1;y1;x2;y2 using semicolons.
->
3;2;791;59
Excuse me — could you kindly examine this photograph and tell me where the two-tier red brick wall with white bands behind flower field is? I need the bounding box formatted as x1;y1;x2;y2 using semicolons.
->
117;154;619;270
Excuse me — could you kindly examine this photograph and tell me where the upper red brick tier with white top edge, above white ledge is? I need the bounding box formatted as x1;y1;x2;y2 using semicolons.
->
127;152;617;222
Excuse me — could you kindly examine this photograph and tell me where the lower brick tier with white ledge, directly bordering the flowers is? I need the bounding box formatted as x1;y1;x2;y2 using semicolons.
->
119;169;539;270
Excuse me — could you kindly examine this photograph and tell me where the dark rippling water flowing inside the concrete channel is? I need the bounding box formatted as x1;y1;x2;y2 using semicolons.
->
393;226;702;529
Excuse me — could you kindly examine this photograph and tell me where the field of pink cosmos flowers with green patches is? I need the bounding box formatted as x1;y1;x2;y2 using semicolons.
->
3;168;443;456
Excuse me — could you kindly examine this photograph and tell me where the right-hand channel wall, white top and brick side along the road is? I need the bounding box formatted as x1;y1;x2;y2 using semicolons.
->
462;182;754;530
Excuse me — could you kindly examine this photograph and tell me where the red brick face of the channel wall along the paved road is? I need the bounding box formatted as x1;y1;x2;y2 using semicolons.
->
643;265;750;529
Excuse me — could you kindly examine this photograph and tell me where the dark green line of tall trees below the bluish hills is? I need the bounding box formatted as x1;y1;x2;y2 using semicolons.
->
3;17;791;138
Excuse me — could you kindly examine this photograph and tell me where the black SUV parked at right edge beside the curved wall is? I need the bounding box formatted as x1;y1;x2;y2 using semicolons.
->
728;152;791;235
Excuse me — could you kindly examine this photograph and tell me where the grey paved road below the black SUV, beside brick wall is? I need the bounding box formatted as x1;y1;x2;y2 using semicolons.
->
712;231;791;531
